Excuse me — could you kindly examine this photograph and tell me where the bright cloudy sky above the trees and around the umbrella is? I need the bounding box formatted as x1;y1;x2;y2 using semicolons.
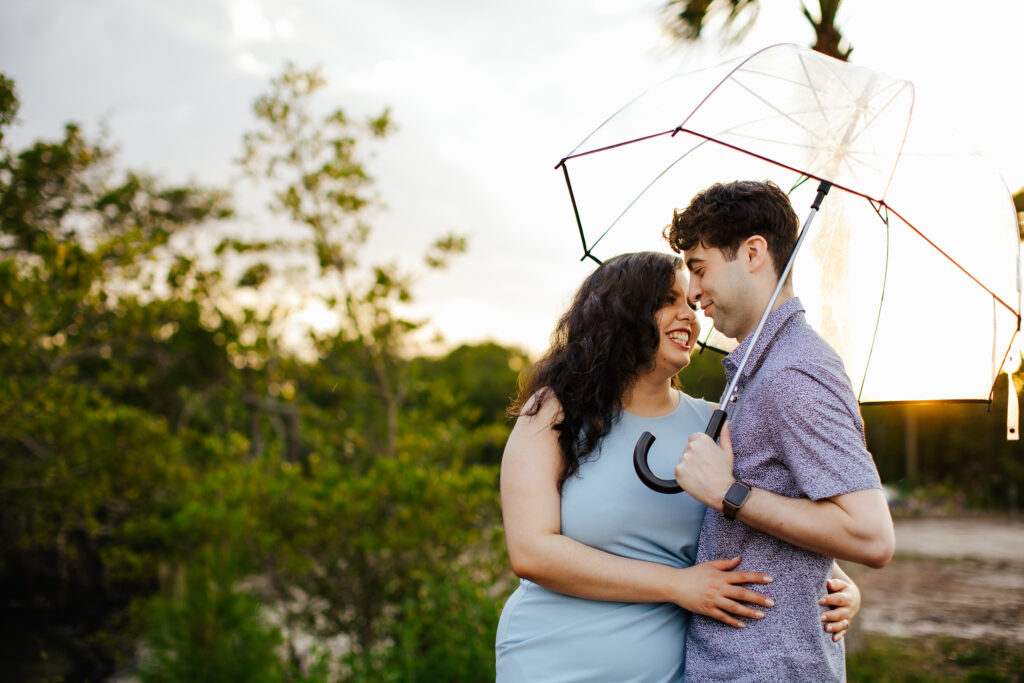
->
0;0;1024;353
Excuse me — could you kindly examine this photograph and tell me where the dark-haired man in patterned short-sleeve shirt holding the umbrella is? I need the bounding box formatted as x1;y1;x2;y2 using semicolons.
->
666;182;894;681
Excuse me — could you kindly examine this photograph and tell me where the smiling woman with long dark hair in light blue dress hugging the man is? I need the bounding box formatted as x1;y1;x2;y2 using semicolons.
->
496;252;860;683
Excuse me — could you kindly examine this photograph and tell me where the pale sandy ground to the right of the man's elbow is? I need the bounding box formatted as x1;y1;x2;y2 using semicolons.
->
844;517;1024;646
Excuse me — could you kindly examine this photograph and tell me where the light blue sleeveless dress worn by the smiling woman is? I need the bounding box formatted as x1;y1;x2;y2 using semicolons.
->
495;393;713;683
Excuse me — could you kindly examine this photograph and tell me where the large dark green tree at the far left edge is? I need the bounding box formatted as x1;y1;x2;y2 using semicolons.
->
0;77;237;678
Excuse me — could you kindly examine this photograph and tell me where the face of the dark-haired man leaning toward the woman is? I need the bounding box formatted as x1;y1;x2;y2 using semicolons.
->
683;244;759;340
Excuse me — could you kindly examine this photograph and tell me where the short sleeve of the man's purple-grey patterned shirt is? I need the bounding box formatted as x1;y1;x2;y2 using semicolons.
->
770;365;882;501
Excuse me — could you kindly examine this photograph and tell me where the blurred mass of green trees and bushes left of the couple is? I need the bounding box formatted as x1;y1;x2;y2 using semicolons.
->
0;67;509;680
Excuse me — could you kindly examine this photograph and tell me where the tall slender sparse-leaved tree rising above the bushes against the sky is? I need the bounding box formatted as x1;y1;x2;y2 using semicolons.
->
235;65;466;458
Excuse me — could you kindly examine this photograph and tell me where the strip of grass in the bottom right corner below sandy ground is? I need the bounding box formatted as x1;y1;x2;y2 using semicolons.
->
846;634;1024;683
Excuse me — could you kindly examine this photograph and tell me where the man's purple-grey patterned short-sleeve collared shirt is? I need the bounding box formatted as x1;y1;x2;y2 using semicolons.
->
686;298;881;681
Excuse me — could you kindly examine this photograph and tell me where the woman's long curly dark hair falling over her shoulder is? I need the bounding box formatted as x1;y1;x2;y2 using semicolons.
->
510;252;683;489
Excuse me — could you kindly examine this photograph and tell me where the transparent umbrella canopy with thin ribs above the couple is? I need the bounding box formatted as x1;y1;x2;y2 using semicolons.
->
558;45;1021;403
